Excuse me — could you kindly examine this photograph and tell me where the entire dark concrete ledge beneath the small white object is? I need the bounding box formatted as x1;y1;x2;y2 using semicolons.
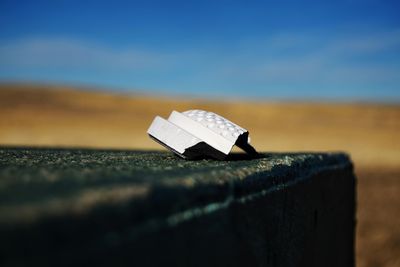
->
0;148;355;266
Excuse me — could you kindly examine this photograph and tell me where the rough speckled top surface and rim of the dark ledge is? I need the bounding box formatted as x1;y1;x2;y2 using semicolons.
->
0;148;352;231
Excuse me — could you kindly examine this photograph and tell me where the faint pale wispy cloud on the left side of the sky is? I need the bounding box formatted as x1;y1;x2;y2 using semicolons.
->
0;38;175;70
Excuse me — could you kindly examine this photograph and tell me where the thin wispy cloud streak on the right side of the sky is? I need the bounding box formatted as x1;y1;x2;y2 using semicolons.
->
214;30;400;82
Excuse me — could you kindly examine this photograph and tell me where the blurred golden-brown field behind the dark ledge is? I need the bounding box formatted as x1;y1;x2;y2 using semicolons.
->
0;84;400;266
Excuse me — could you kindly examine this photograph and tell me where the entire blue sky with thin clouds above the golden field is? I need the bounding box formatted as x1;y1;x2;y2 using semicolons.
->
0;0;400;102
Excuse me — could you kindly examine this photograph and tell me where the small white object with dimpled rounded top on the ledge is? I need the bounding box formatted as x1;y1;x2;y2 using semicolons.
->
147;110;257;160
